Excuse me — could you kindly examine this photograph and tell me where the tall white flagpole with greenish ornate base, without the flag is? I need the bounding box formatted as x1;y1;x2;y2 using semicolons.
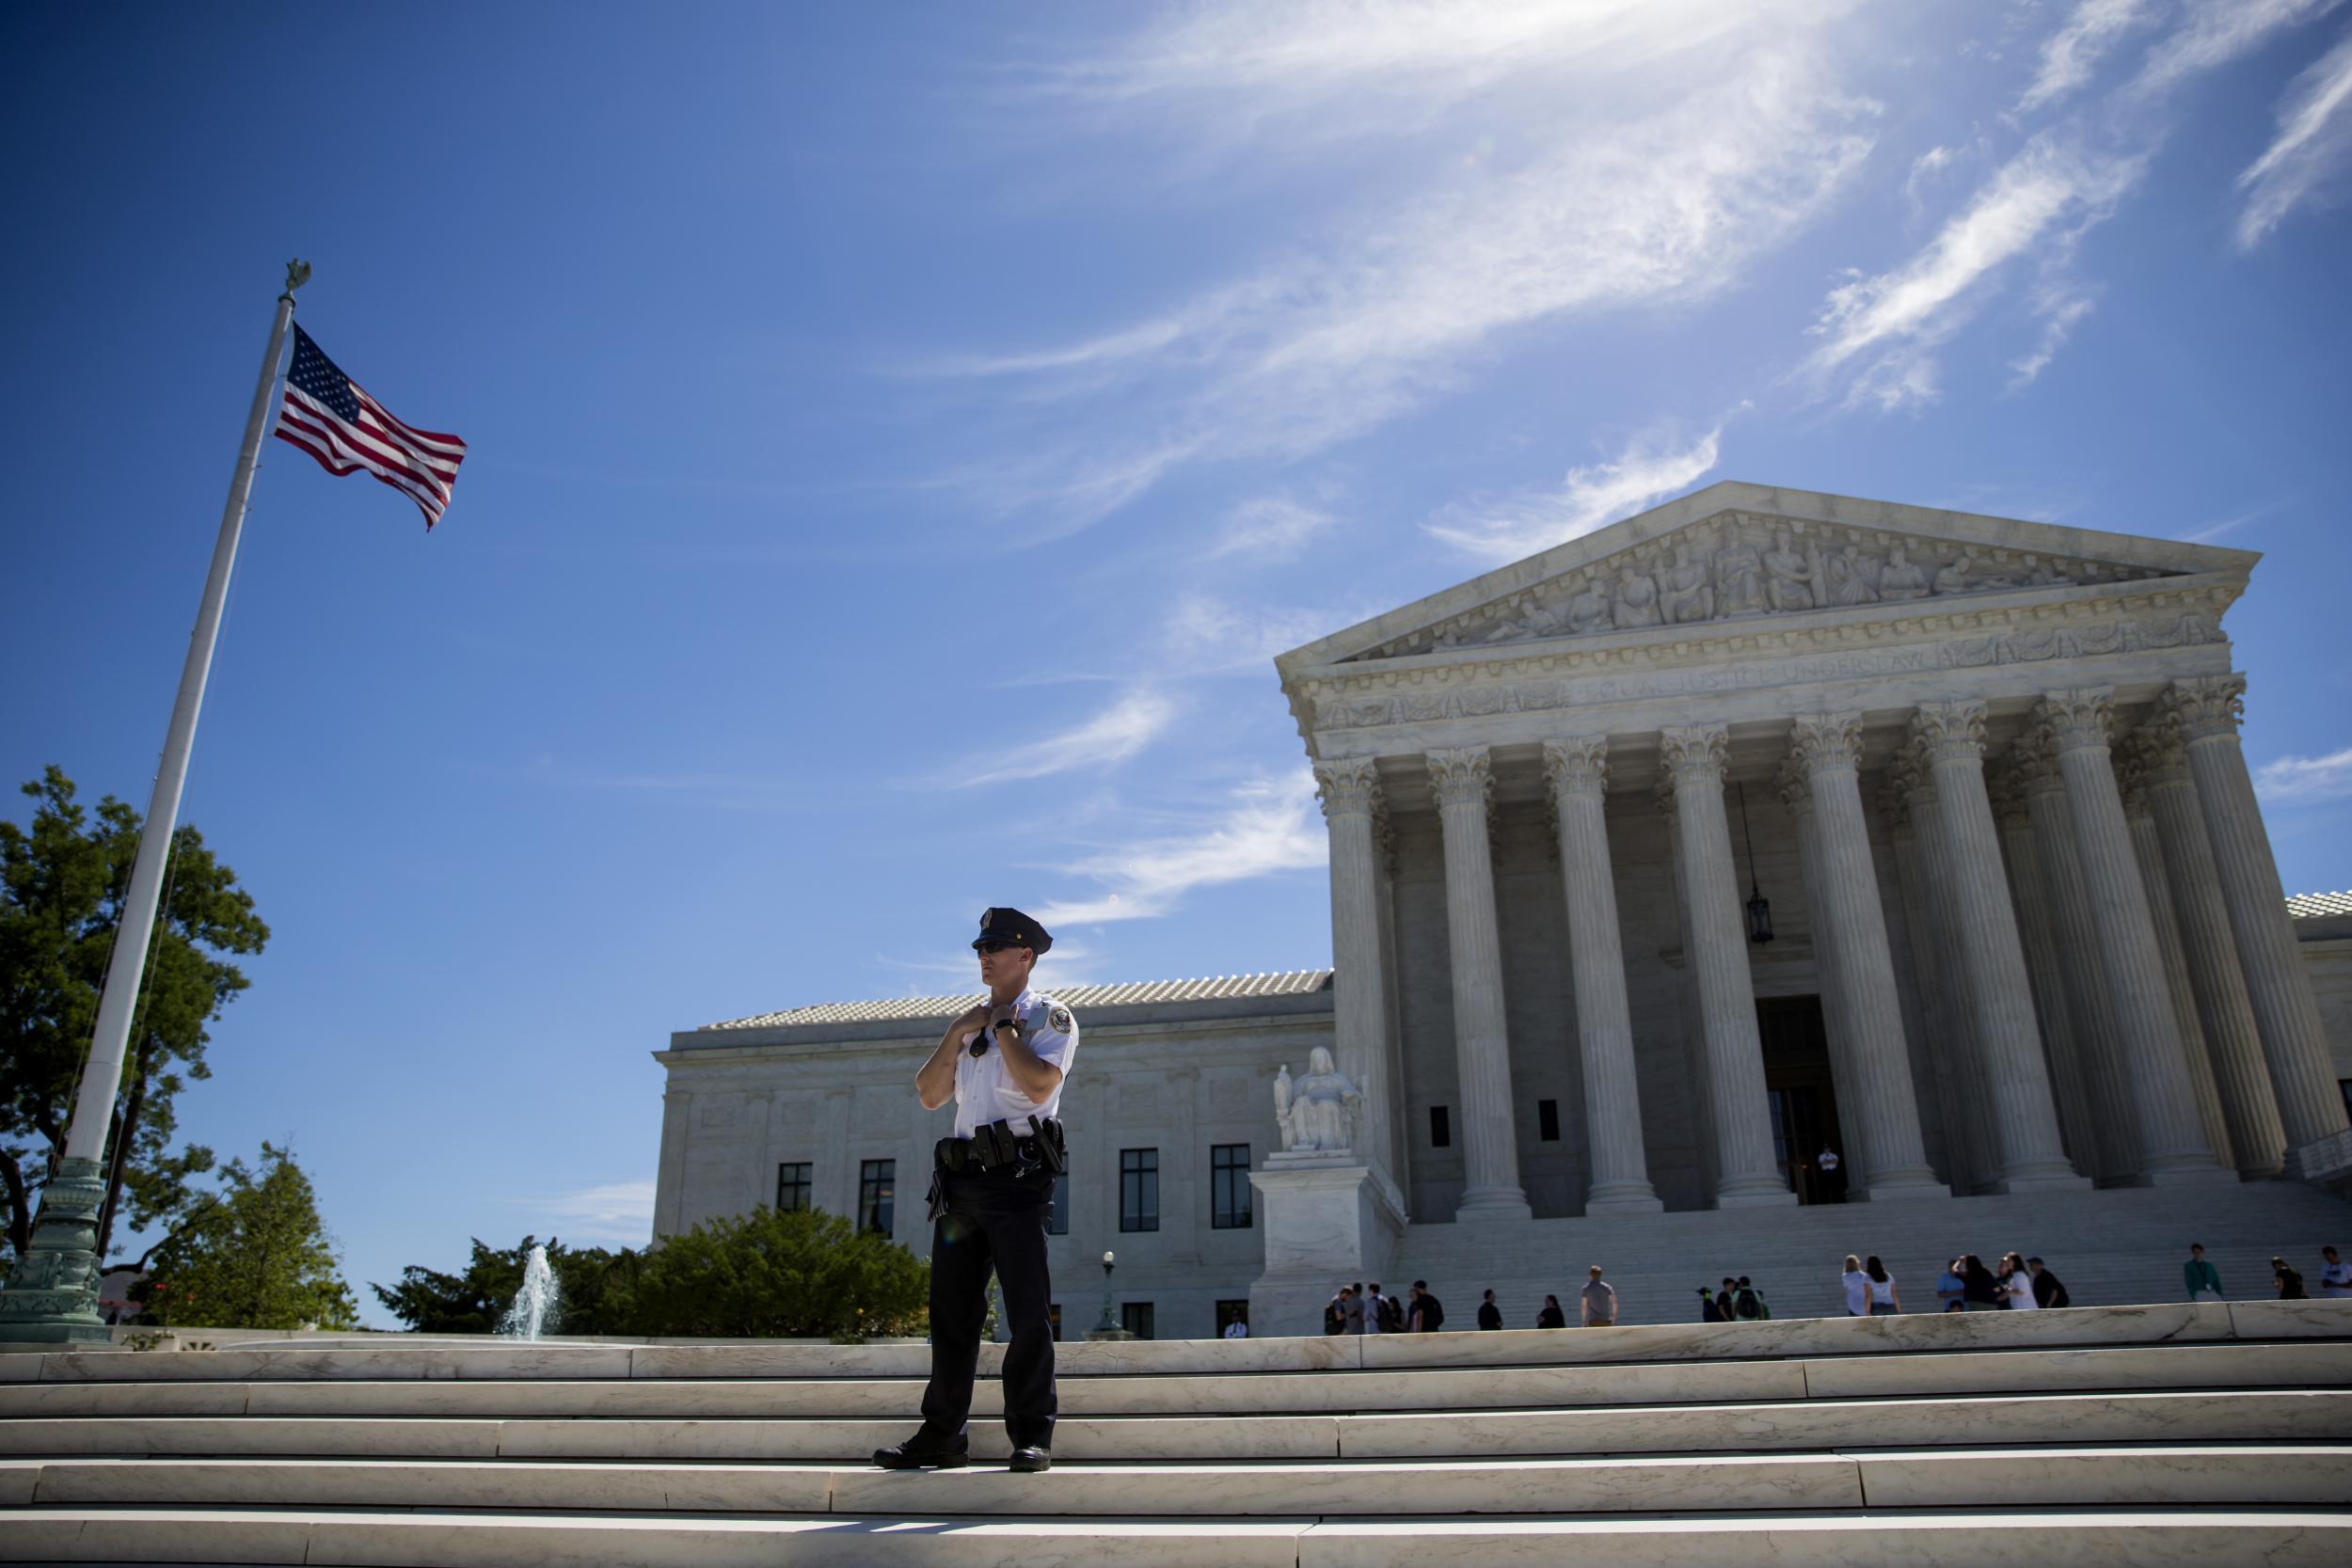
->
0;261;310;1342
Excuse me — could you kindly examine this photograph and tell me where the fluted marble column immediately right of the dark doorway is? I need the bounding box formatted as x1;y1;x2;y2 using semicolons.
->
1790;712;1952;1201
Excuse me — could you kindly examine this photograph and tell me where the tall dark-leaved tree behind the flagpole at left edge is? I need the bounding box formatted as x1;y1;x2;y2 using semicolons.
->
0;767;271;1258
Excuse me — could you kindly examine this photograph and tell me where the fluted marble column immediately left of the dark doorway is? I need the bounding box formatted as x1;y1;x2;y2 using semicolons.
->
1659;724;1797;1209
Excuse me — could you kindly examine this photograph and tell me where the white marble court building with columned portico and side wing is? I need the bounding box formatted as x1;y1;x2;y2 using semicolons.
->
654;482;2352;1338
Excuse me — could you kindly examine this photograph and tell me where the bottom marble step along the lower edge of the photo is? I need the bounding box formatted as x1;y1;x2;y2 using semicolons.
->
0;1507;2352;1568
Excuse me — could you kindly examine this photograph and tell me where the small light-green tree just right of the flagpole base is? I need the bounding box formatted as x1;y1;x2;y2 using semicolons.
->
141;1143;360;1328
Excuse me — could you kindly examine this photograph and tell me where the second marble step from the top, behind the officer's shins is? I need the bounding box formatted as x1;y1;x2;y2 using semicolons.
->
0;1340;2352;1420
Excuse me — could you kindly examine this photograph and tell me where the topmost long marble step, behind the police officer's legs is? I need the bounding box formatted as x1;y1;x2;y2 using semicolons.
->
0;1300;2352;1385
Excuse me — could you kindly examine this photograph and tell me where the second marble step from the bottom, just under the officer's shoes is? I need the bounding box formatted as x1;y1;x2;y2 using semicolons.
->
0;1444;2352;1526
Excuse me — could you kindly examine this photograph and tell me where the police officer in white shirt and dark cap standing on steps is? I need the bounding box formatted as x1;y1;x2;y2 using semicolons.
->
875;910;1077;1472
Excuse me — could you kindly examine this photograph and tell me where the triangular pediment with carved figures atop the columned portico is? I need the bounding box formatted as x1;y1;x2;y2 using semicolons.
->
1278;480;2258;677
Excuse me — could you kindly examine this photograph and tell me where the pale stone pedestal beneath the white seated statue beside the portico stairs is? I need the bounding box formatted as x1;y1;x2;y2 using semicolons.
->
1249;1149;1405;1338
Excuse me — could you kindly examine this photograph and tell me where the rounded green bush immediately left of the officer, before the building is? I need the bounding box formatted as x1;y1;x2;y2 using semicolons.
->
612;1204;931;1340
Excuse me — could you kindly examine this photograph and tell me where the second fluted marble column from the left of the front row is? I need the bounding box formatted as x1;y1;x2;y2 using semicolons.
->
1428;745;1532;1220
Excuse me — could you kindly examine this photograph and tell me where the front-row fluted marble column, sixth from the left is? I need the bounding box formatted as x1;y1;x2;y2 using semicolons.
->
1913;701;2089;1192
